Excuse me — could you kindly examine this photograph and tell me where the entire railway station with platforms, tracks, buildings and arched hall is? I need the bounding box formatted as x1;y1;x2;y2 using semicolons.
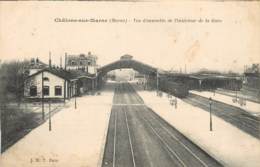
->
0;52;260;167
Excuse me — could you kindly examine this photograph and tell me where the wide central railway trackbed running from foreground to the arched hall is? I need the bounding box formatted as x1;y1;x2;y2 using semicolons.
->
102;83;222;167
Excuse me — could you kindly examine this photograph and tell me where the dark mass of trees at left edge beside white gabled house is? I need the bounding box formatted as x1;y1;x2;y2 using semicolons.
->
0;61;29;151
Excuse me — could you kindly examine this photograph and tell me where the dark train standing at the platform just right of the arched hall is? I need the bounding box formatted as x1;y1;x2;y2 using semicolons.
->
159;79;189;98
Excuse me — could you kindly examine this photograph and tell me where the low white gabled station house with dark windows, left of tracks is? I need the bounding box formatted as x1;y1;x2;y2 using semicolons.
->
24;68;78;99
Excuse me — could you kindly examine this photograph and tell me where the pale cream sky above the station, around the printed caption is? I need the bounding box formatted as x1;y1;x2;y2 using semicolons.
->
0;1;260;72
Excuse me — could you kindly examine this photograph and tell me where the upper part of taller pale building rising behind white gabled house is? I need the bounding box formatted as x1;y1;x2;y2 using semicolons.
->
65;52;97;74
